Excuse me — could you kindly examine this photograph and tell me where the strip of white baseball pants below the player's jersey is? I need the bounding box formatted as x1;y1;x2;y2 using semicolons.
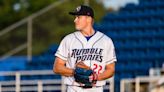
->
66;86;103;92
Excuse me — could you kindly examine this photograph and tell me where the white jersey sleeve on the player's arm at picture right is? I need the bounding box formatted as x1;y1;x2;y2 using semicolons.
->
106;39;117;64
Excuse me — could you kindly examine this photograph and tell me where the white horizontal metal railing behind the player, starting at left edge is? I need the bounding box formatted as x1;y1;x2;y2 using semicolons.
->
0;70;114;92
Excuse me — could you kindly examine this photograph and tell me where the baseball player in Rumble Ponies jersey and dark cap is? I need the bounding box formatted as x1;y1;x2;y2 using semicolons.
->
53;5;117;92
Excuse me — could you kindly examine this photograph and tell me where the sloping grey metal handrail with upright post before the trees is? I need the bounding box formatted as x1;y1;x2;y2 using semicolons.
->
0;0;68;61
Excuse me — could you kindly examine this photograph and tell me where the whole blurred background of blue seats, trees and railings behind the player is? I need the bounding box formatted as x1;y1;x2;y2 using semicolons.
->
0;0;164;92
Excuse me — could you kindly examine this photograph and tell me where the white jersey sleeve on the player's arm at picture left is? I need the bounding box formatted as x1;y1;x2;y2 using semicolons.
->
55;38;68;61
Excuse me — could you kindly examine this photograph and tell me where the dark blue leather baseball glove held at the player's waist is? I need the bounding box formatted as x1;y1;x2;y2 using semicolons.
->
74;61;97;86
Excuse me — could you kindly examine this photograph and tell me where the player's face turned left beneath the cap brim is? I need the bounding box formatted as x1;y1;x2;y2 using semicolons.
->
74;16;88;30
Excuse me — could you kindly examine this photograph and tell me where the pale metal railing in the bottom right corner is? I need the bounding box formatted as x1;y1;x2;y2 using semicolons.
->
120;68;164;92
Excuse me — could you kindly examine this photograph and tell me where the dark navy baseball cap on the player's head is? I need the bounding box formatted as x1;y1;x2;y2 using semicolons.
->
69;5;94;18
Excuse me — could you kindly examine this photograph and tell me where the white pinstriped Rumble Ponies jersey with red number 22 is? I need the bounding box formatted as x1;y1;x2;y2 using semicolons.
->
55;31;117;86
